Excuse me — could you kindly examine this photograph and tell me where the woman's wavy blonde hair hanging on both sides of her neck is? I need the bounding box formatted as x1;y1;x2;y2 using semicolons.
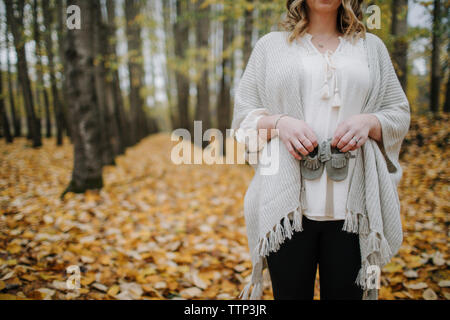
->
280;0;366;43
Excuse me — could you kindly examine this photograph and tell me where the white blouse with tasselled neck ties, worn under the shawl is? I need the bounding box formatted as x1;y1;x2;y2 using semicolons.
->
235;33;369;220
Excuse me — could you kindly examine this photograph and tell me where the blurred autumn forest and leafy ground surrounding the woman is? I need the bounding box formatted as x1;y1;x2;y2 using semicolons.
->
0;0;450;299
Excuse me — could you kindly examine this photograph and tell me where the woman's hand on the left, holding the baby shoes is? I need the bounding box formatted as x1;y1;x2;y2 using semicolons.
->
277;116;318;160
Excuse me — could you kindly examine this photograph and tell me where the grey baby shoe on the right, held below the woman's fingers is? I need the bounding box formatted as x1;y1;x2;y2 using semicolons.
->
322;138;356;181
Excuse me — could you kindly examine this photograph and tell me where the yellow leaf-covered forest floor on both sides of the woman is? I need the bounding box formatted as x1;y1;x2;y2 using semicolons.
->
0;117;450;299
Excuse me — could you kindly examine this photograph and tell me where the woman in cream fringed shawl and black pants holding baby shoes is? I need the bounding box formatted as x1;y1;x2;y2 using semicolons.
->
232;0;410;300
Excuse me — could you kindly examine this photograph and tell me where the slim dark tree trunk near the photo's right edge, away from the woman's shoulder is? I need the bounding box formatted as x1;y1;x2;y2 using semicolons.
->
430;0;441;113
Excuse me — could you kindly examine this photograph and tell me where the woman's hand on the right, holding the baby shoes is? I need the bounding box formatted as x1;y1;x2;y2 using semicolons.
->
331;114;375;152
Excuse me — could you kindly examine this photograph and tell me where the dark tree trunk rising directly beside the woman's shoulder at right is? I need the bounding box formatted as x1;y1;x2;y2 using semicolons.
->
391;0;408;92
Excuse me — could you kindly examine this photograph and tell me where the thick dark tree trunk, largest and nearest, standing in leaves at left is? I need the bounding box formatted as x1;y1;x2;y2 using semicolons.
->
62;0;103;197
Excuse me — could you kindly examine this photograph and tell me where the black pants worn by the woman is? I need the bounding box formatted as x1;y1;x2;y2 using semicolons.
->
267;217;363;300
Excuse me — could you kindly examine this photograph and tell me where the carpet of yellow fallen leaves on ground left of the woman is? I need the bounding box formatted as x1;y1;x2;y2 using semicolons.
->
0;134;260;299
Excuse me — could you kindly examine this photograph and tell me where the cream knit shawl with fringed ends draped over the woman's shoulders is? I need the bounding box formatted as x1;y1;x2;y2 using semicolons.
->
232;31;410;299
